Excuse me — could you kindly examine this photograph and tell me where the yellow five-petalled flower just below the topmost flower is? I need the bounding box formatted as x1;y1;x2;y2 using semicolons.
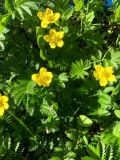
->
43;29;64;48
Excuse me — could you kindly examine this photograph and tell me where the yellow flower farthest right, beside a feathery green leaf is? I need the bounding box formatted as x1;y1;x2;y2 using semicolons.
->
93;65;116;86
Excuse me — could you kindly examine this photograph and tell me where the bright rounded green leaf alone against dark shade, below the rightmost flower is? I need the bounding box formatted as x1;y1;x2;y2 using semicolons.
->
77;115;93;127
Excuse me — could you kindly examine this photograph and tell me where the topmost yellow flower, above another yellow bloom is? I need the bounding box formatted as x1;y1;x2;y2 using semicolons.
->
37;8;60;28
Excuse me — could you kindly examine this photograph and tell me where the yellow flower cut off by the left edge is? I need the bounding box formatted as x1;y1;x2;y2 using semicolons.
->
0;94;9;116
